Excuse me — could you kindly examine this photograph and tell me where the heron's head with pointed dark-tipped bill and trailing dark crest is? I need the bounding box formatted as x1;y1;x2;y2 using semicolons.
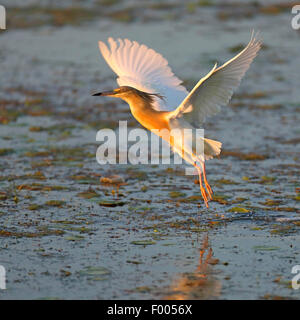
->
93;86;163;104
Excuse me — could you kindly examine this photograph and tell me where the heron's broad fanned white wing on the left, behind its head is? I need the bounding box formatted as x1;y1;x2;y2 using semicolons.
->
99;38;188;111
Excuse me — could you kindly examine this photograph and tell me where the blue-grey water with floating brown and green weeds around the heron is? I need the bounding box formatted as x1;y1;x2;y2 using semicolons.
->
0;1;300;299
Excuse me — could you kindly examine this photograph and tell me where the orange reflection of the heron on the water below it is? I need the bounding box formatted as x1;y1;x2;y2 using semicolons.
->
164;235;222;300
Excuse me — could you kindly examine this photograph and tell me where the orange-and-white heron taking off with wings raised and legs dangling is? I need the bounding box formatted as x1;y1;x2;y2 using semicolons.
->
93;33;262;207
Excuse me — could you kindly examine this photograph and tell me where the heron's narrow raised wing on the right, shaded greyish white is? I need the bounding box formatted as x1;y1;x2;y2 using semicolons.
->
170;35;261;123
